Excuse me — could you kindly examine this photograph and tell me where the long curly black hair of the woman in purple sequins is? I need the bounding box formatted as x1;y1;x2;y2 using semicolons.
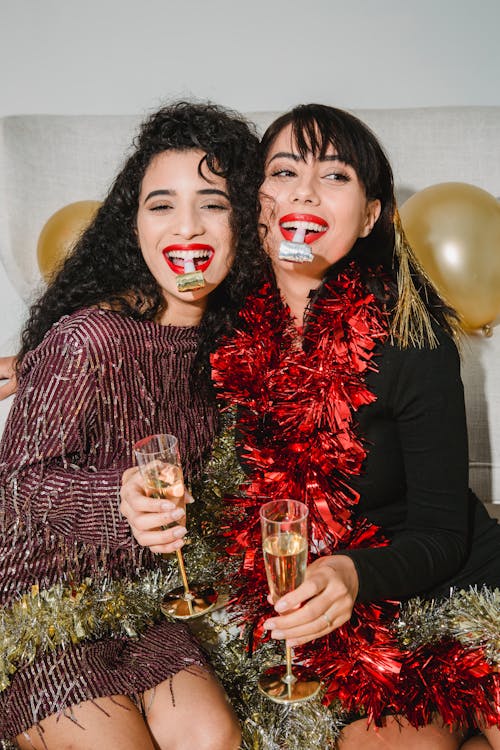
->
18;101;265;373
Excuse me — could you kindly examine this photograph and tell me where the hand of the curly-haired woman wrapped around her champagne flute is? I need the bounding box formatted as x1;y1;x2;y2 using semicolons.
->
120;467;193;554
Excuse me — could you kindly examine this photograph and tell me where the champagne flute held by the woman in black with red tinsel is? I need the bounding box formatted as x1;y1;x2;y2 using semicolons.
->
258;500;321;703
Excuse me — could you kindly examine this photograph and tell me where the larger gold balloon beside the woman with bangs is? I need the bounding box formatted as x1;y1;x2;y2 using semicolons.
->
400;182;500;330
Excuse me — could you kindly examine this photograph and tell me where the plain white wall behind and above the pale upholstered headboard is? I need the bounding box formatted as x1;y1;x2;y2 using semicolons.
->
0;0;500;354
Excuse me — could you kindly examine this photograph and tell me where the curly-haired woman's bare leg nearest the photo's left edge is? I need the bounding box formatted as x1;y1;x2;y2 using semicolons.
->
16;695;154;750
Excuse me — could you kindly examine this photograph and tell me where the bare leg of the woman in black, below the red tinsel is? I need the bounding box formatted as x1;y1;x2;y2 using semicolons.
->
338;716;461;750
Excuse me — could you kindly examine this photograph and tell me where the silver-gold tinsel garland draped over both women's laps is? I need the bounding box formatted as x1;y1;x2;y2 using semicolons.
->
0;414;500;750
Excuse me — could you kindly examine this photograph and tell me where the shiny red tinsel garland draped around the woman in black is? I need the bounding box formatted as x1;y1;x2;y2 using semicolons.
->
212;266;498;726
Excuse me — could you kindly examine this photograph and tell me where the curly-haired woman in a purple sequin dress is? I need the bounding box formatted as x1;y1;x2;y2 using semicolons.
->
0;102;262;750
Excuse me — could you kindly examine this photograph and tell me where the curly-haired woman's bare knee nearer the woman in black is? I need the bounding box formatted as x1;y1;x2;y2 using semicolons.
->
144;671;241;750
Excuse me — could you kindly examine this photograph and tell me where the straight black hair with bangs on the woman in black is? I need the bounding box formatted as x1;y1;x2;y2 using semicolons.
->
261;104;456;334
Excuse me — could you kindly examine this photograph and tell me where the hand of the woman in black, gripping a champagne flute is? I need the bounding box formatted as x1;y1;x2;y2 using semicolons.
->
264;555;359;646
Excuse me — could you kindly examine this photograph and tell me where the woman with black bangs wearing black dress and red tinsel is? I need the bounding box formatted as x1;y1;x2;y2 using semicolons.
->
122;104;500;750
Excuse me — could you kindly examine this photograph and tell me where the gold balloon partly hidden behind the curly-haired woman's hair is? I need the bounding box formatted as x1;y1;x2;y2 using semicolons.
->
36;201;101;281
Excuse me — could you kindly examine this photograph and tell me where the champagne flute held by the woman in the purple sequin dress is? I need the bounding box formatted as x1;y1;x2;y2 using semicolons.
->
134;434;218;620
